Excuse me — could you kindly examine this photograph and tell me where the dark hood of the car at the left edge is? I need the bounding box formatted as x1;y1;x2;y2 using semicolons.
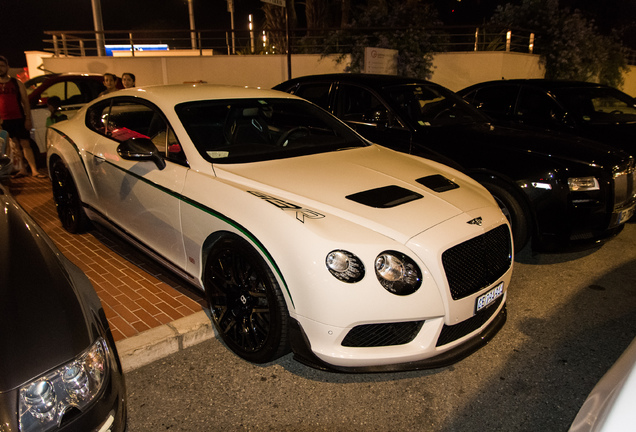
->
0;188;95;393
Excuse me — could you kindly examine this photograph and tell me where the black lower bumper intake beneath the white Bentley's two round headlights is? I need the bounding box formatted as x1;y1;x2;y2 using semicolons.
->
342;321;424;348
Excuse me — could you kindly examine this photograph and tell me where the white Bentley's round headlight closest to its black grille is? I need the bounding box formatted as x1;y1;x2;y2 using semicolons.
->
375;251;422;295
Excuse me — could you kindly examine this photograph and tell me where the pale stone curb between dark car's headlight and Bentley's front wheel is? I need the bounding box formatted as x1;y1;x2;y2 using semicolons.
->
115;311;215;372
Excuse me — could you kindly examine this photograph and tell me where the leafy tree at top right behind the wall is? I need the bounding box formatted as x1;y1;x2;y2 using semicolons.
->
491;0;628;87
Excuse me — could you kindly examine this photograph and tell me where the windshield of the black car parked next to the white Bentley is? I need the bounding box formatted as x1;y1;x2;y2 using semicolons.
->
387;84;488;127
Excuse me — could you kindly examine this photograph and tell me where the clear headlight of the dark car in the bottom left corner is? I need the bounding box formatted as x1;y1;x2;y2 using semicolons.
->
18;338;110;432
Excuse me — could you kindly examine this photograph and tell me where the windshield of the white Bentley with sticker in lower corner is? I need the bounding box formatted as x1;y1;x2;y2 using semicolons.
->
175;99;367;163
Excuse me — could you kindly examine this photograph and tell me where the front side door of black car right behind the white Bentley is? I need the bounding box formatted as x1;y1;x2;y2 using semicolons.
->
333;83;411;153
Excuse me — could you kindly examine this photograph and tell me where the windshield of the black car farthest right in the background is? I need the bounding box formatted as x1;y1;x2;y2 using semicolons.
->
553;87;636;124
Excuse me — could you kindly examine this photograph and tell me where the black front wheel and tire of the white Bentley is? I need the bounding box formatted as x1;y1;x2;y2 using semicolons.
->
203;236;289;363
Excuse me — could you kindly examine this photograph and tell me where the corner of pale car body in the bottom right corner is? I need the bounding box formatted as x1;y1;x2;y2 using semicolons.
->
570;340;636;432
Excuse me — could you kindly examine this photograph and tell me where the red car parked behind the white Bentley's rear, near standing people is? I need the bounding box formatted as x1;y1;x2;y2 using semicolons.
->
24;73;105;153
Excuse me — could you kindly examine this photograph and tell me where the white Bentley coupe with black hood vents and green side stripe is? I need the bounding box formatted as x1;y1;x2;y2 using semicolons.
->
47;84;513;372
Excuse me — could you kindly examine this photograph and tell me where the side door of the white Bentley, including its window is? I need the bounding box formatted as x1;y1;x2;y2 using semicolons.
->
87;97;188;268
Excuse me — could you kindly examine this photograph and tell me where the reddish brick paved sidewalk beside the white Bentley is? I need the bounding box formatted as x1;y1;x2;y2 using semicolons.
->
9;177;207;341
